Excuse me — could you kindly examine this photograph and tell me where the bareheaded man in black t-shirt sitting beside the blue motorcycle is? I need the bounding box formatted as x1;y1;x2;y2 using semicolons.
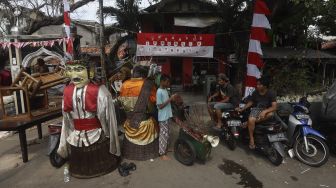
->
237;78;277;149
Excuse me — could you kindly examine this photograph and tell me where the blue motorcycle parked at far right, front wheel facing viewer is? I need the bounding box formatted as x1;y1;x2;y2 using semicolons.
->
276;98;329;167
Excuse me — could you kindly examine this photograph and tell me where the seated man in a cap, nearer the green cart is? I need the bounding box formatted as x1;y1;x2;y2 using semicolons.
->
208;73;238;130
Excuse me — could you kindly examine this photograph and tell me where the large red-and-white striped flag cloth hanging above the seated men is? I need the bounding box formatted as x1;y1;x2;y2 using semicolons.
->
245;0;271;97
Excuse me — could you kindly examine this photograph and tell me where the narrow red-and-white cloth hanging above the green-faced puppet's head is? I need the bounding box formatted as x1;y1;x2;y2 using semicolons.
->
63;0;73;61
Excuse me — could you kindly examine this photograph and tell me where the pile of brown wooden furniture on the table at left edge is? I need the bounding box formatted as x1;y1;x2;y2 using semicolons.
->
0;67;68;120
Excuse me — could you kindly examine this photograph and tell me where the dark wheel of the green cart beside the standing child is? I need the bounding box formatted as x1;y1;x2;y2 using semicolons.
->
174;139;196;166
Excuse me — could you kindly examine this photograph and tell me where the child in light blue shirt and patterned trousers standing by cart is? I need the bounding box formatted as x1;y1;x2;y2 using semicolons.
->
156;75;176;160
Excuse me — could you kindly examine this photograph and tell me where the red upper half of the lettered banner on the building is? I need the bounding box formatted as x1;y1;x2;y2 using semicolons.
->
137;33;215;47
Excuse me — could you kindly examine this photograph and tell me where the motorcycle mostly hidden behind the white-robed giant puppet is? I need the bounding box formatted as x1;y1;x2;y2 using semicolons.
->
48;124;66;168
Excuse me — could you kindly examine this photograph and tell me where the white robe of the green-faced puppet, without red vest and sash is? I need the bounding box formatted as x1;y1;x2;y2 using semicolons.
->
57;85;120;158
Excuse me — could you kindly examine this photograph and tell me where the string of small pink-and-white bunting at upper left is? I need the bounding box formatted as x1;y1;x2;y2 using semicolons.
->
0;38;71;49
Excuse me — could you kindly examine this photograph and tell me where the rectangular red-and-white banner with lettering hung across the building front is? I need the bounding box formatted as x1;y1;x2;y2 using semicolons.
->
136;33;215;58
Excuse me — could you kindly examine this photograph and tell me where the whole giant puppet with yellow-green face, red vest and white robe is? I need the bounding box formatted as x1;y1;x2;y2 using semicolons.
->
57;61;120;178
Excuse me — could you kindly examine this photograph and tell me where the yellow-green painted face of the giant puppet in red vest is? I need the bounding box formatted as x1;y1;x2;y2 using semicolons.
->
66;65;90;88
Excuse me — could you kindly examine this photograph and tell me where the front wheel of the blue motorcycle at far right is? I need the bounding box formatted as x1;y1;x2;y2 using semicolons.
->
293;135;329;167
